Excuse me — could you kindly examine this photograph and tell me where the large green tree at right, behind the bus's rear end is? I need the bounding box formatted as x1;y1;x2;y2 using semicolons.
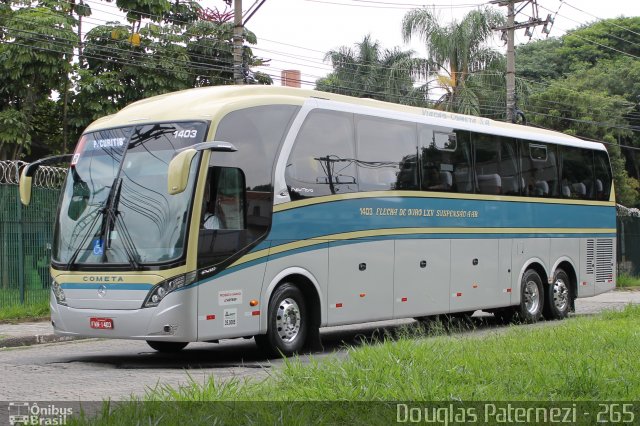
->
516;17;640;206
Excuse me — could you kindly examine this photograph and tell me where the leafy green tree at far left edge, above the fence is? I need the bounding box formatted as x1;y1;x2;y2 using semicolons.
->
0;2;77;160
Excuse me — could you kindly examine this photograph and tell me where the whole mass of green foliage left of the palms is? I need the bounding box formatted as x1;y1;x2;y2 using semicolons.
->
0;0;272;159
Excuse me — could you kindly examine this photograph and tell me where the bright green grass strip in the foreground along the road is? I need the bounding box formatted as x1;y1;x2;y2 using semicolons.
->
79;305;640;425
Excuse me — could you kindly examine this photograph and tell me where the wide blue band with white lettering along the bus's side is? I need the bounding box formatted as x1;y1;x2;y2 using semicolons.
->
268;197;616;240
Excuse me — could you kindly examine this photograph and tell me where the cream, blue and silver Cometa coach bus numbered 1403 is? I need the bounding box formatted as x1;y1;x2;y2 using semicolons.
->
20;86;616;356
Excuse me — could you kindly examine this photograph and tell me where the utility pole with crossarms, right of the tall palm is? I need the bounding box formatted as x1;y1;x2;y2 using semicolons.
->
490;0;553;122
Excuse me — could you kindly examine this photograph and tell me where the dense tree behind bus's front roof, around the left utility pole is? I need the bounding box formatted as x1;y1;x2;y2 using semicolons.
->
71;0;272;145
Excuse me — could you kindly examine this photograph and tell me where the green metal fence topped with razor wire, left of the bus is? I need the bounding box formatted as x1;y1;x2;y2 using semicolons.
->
0;161;65;309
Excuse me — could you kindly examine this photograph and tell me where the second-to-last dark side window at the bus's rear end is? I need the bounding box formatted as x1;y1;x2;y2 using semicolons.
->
559;146;594;200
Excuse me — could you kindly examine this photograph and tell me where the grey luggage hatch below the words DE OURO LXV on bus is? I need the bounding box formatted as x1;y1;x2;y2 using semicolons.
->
393;239;451;318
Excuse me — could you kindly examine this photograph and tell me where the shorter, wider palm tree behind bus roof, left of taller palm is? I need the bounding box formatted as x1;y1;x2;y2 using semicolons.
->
316;35;429;105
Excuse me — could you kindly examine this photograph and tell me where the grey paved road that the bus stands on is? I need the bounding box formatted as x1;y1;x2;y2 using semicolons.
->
0;292;640;401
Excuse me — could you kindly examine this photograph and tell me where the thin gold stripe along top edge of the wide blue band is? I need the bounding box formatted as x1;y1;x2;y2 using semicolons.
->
273;189;616;213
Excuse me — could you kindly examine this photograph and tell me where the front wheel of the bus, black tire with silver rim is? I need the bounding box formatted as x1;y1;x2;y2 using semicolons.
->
255;283;309;356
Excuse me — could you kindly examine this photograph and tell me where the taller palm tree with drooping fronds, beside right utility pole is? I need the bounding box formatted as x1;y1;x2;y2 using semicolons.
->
402;7;504;115
